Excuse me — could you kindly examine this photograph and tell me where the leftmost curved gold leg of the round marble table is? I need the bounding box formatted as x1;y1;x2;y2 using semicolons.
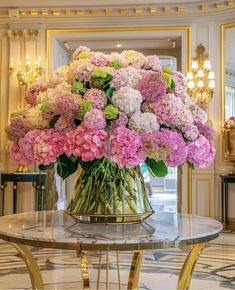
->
11;243;44;290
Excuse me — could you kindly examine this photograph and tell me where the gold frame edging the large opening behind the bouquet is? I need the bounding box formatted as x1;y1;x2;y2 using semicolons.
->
45;26;192;214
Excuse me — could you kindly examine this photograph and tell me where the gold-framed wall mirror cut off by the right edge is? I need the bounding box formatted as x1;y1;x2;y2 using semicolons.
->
221;22;235;121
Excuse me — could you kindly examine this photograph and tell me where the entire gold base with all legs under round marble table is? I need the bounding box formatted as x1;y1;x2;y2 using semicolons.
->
11;243;206;290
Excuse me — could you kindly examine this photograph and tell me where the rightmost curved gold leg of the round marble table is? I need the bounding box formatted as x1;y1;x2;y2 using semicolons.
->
177;243;206;290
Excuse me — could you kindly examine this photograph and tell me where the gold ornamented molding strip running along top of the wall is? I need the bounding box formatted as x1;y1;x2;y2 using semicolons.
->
0;0;234;19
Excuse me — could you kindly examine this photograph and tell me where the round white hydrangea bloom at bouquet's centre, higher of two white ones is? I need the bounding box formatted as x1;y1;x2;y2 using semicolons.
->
112;87;143;116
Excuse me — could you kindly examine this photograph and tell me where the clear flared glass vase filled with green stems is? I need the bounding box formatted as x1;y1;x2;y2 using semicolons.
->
66;158;153;223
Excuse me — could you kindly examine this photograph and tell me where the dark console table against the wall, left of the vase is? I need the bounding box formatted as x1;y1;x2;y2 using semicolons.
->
1;172;46;215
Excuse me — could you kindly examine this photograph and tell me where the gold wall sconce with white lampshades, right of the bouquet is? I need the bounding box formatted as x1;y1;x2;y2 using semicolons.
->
187;44;215;110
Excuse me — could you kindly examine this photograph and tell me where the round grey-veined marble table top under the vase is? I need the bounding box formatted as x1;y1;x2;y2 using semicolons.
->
0;211;222;251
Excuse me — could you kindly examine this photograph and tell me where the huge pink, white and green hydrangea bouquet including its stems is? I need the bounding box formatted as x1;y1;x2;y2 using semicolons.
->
6;47;215;221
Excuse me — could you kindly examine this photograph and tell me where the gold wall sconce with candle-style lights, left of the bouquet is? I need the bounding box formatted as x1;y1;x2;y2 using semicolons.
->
9;55;43;88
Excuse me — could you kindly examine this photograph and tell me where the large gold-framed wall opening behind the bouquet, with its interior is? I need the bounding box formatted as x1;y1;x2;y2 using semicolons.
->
46;27;191;212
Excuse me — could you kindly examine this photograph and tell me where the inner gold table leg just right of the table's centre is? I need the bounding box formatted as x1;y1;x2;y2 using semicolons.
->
127;251;144;290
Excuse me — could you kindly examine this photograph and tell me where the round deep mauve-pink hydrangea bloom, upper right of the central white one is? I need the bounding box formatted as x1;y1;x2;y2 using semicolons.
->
137;71;166;102
